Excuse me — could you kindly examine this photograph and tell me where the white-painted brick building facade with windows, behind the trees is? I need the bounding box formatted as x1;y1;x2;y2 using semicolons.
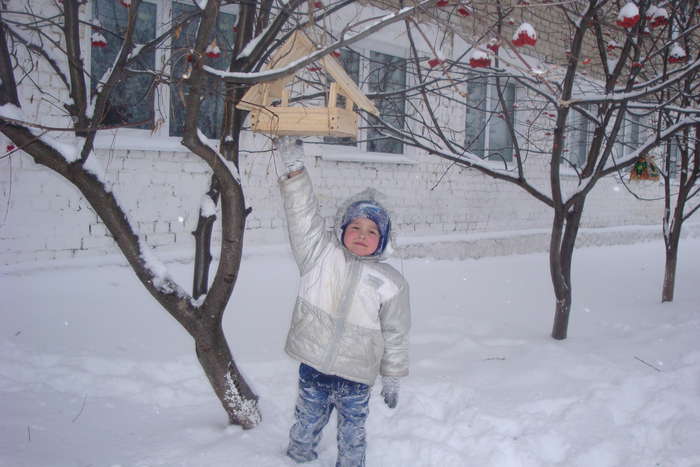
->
0;0;688;265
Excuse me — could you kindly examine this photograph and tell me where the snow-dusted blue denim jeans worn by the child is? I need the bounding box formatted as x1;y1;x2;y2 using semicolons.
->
287;363;370;467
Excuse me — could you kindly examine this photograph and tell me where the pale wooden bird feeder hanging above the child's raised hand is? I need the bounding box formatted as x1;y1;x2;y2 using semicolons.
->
236;31;379;138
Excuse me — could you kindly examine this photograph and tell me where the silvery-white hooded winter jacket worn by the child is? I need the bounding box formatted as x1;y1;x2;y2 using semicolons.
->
280;170;410;385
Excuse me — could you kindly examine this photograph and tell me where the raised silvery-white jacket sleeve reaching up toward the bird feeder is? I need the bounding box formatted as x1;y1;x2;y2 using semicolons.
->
279;169;332;275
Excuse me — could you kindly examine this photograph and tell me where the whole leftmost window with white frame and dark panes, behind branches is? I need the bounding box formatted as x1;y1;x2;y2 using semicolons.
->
90;0;236;138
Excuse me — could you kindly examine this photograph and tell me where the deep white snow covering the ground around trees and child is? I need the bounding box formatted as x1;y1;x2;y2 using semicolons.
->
0;239;700;467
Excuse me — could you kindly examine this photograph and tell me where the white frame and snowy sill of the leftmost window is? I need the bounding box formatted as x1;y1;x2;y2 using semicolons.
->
90;0;239;151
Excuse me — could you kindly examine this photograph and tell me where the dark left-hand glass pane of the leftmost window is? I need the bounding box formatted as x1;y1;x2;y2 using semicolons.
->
90;0;156;129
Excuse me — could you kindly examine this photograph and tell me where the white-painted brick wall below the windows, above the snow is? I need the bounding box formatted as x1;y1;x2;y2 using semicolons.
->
0;144;680;265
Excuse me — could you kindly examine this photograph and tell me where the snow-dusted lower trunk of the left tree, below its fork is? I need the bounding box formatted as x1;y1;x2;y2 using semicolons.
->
194;320;261;429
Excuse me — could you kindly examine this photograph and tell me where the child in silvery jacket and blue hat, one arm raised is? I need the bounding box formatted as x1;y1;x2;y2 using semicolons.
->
278;137;410;467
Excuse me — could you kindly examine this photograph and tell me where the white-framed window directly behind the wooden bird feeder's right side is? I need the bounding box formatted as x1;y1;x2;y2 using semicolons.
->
323;45;407;154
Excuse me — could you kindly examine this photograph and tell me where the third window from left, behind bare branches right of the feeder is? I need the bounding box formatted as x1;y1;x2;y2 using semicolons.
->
465;77;515;162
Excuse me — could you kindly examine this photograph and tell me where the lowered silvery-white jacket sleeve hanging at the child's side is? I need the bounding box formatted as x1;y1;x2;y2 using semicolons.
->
379;280;411;376
